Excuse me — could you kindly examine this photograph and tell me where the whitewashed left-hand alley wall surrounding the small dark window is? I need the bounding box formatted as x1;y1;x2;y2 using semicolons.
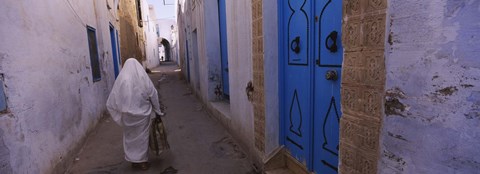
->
0;0;116;174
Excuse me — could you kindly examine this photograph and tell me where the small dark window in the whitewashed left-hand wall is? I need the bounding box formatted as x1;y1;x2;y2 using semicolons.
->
87;26;102;82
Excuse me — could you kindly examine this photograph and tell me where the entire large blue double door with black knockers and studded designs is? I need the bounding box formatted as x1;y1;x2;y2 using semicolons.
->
278;0;343;174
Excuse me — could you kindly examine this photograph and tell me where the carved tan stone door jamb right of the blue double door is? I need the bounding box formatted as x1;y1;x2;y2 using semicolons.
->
339;0;387;174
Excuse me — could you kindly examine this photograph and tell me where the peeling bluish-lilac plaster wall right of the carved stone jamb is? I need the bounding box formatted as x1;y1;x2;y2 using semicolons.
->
379;0;480;173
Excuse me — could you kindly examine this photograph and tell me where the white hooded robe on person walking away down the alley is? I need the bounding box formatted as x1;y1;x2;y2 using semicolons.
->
107;58;163;163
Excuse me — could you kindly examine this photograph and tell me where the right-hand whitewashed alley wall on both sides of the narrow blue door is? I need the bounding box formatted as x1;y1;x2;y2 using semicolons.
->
177;0;258;164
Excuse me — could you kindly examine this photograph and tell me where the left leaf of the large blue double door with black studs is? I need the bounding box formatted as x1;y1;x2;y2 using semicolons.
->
280;0;313;163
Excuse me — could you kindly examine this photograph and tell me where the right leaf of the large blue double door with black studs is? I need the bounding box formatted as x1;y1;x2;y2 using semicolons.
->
313;0;343;174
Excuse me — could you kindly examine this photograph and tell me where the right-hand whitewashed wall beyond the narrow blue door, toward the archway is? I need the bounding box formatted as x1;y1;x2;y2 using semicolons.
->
177;0;222;102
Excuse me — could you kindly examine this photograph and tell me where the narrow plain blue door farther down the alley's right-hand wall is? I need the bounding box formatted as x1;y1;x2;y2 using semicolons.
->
218;0;230;96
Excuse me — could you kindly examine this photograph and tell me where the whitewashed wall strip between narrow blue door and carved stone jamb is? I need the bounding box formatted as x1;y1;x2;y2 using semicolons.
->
226;1;255;161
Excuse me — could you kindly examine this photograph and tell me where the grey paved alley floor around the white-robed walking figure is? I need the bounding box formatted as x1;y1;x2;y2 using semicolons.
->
67;63;255;174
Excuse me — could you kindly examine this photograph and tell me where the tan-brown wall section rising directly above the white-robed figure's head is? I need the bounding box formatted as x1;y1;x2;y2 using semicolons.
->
118;0;144;65
